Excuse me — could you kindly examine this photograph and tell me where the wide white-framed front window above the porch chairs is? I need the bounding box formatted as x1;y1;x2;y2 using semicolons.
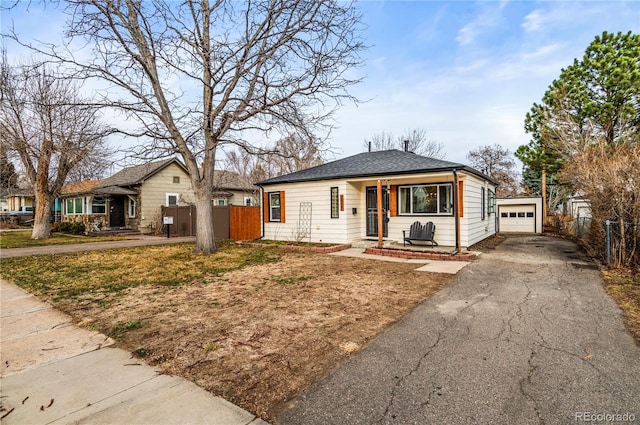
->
398;183;453;215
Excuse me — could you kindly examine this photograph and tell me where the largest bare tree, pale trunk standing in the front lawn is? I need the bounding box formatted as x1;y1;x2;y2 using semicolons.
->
14;0;364;253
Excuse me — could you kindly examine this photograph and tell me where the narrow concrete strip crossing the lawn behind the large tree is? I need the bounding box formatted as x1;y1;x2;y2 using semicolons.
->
0;235;196;258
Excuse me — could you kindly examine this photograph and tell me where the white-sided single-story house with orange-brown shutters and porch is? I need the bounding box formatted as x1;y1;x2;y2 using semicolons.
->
258;150;497;249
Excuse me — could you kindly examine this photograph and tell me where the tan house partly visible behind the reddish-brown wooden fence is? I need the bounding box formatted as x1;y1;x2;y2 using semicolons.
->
213;170;260;206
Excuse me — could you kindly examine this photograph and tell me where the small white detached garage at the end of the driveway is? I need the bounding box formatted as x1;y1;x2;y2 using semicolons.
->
496;198;542;233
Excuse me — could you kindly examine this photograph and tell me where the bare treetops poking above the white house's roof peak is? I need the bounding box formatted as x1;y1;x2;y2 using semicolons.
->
363;128;446;159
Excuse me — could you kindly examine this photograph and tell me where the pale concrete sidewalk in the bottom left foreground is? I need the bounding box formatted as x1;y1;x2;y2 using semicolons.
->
0;279;266;425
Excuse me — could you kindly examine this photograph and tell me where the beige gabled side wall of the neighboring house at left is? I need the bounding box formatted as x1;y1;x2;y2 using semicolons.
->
137;164;195;232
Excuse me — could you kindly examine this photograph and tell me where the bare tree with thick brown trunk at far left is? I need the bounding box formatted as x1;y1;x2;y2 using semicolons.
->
0;55;109;239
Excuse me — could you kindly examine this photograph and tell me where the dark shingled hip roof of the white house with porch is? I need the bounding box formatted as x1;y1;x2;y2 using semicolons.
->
257;149;498;186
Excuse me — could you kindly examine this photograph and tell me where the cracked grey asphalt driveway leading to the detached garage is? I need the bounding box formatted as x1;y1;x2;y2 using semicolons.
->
279;236;640;424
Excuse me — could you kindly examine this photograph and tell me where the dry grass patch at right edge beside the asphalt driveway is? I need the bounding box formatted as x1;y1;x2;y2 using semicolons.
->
602;269;640;345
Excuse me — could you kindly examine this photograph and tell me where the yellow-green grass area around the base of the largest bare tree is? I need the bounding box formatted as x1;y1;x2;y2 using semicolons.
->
2;243;279;301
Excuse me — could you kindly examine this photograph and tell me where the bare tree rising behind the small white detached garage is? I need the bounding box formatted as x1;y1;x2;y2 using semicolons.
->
467;144;520;197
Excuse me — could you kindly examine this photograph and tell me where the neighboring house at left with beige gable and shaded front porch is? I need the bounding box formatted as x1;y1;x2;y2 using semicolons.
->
60;158;194;233
